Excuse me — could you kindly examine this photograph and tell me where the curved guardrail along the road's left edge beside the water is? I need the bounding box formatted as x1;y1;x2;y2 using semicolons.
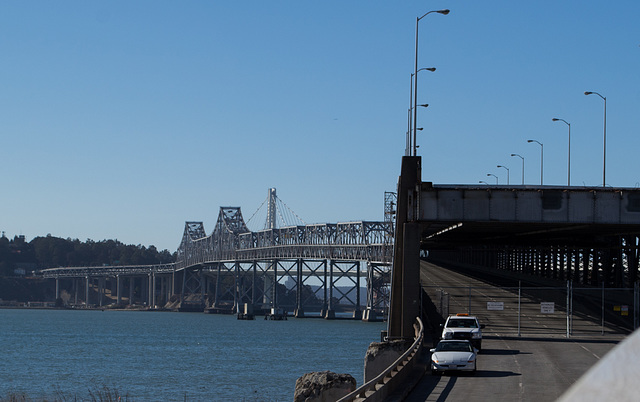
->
338;317;424;402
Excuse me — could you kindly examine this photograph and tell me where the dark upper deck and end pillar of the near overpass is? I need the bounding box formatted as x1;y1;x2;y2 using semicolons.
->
389;157;640;338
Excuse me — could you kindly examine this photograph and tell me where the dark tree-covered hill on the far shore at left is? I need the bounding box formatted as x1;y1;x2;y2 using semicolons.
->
0;234;176;276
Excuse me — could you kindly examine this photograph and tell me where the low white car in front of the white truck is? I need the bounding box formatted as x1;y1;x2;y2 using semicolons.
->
430;340;478;374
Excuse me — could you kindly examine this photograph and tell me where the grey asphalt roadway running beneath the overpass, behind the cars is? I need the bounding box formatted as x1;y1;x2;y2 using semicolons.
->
406;262;625;402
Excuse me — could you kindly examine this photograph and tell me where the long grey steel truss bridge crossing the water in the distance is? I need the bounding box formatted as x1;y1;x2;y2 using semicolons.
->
40;189;395;320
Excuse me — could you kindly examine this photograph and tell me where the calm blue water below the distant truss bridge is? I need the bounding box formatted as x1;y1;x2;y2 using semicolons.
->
0;309;386;401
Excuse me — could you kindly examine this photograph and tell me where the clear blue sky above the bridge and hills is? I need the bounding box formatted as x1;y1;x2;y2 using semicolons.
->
0;0;640;251
